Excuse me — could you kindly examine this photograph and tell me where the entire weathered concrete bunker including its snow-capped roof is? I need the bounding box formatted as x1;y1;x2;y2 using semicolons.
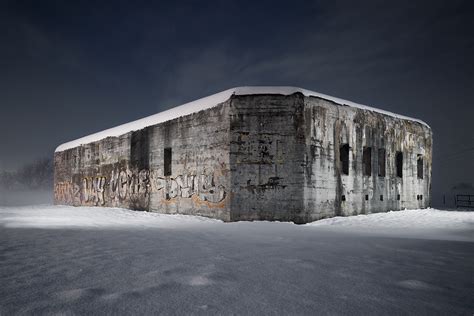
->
54;87;432;223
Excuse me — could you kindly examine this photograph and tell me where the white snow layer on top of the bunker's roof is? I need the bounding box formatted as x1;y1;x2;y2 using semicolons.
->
56;86;428;152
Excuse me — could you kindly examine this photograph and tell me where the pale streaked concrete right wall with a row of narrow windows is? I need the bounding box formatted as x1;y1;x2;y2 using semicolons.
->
304;97;432;220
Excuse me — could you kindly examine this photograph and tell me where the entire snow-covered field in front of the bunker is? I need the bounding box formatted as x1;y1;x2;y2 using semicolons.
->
0;205;474;315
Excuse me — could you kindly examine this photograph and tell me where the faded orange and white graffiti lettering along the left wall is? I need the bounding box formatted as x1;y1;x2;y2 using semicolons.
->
54;169;226;206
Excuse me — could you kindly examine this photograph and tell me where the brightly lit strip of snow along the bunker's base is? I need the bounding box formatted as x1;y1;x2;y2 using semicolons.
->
0;205;474;241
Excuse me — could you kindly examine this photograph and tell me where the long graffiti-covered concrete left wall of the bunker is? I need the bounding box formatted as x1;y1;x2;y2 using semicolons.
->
55;103;230;220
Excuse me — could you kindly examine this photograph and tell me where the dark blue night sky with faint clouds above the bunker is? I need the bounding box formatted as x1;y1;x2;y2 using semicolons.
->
0;0;474;203
